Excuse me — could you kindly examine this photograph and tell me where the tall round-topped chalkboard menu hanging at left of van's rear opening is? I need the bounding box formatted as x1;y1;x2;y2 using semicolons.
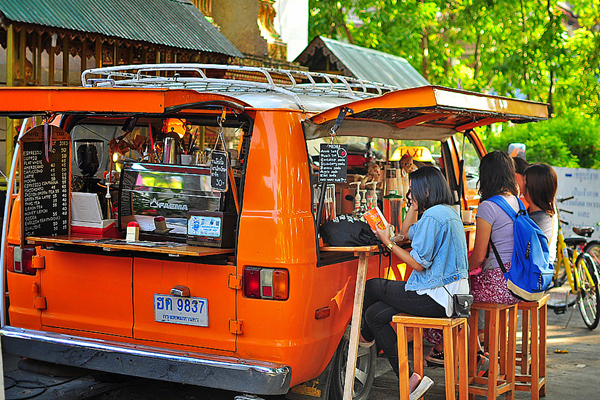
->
20;126;71;242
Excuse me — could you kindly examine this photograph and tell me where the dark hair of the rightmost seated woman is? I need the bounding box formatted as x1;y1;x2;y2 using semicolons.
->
525;164;558;215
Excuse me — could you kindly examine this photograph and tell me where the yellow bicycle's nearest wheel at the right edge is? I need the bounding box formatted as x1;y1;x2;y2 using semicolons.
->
575;253;600;329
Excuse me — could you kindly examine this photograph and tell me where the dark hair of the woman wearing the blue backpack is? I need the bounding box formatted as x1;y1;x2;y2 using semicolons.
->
479;151;519;201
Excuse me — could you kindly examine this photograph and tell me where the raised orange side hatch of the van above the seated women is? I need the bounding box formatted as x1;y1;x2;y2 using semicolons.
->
303;86;548;140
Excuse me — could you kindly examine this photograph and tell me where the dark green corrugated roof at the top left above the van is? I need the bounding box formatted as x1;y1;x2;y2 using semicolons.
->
0;0;243;57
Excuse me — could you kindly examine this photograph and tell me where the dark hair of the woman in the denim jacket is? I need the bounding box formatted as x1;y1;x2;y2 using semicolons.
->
408;166;452;215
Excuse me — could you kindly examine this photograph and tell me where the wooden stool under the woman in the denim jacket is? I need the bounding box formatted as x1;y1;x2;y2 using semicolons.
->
392;314;469;400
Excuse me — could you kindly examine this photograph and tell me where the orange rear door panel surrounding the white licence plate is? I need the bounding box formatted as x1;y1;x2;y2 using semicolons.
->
133;257;235;352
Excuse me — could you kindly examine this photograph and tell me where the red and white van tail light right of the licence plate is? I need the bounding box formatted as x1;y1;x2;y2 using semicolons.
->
244;267;289;300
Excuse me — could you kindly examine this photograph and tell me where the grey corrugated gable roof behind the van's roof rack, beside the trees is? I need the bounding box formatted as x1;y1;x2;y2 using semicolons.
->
295;36;429;89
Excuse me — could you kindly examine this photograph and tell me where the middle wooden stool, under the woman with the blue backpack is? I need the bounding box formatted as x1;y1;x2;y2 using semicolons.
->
469;303;517;399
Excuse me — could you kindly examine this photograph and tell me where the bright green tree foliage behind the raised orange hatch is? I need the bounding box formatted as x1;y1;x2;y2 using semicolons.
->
309;0;600;168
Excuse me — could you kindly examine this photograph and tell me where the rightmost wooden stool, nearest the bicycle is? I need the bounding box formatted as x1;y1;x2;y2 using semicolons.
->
515;294;550;400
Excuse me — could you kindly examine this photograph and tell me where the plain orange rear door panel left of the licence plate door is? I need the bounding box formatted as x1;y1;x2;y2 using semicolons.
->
38;249;133;337
